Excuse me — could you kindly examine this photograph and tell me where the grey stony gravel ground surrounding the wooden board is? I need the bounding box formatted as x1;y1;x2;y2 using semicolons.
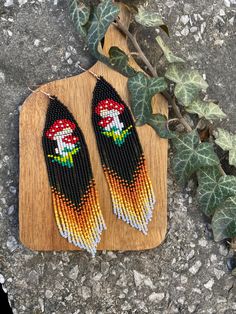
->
0;0;236;314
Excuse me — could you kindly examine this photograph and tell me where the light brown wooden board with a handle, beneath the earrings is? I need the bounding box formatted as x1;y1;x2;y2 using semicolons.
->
19;3;167;251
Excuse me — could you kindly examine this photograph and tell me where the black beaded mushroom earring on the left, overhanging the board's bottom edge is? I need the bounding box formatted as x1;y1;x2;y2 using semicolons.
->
42;97;106;256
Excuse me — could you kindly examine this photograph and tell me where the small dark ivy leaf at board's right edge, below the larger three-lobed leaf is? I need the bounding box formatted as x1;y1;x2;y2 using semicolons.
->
147;113;175;138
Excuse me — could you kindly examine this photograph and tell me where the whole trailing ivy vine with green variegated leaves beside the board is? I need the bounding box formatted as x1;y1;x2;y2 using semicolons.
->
69;0;236;273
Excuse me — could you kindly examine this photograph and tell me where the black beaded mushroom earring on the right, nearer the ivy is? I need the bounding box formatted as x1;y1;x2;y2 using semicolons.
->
92;77;155;234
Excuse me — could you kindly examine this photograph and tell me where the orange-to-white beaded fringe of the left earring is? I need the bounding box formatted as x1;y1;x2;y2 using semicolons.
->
51;180;106;256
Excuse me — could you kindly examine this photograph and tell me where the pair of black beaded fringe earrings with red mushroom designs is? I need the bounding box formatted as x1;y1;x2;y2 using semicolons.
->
42;74;155;256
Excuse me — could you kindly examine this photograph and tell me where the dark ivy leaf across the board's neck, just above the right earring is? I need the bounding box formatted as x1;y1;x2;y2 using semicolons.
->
109;46;137;77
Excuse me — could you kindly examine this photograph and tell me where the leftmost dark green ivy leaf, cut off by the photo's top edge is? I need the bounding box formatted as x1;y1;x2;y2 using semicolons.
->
69;0;90;36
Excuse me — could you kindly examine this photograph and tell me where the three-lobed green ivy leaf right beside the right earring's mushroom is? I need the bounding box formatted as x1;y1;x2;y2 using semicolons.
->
128;72;167;125
